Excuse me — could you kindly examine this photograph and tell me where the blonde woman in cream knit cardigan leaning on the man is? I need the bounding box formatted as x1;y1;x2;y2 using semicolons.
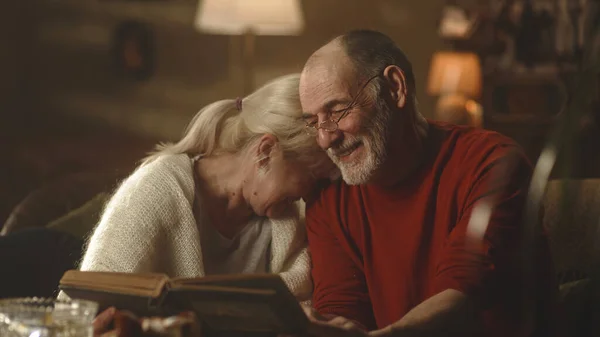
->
80;75;335;301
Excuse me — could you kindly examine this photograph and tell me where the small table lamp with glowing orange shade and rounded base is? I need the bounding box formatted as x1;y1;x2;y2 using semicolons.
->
427;51;482;127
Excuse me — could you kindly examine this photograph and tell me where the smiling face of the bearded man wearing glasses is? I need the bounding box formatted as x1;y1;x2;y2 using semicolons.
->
300;56;391;185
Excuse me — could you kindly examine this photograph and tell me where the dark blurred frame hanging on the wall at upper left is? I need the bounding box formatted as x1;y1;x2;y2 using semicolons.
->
112;21;156;81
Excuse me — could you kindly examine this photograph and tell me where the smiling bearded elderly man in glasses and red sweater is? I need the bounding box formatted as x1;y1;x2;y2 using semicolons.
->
300;31;556;337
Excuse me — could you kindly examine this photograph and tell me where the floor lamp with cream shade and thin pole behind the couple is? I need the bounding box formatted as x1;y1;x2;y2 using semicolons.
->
194;0;304;94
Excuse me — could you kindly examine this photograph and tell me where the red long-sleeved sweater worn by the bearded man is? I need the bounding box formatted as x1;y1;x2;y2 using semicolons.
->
306;122;556;336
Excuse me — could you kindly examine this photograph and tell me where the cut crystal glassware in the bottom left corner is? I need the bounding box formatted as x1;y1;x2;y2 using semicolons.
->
0;297;98;337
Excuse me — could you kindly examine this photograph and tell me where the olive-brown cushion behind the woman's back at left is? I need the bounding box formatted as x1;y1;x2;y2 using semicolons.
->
48;193;110;239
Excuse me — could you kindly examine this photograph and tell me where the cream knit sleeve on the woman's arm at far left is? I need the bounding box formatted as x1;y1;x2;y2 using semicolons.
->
80;160;183;272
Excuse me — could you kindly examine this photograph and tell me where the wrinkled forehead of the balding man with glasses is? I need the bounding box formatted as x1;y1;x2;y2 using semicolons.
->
300;59;354;115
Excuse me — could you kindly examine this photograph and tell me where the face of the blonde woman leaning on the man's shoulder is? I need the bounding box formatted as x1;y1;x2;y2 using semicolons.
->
247;135;334;218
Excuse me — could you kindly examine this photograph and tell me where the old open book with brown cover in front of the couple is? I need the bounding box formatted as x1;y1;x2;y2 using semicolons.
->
59;270;311;334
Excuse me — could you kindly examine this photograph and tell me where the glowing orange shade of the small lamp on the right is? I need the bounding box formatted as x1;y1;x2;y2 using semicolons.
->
427;52;481;98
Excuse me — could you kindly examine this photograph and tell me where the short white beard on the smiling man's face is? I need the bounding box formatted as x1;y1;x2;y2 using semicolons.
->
327;102;391;185
